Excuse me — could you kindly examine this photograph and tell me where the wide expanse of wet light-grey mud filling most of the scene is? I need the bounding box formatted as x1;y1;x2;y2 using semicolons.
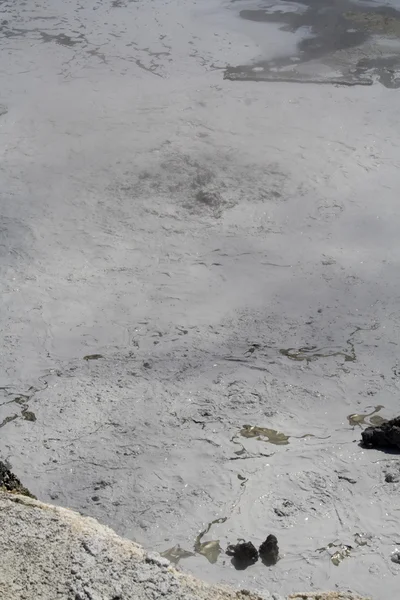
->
0;0;400;600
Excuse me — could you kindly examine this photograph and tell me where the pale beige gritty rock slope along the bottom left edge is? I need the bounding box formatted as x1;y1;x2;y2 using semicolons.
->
0;491;368;600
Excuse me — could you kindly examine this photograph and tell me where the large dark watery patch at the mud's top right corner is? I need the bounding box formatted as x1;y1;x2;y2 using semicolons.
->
224;0;400;88
